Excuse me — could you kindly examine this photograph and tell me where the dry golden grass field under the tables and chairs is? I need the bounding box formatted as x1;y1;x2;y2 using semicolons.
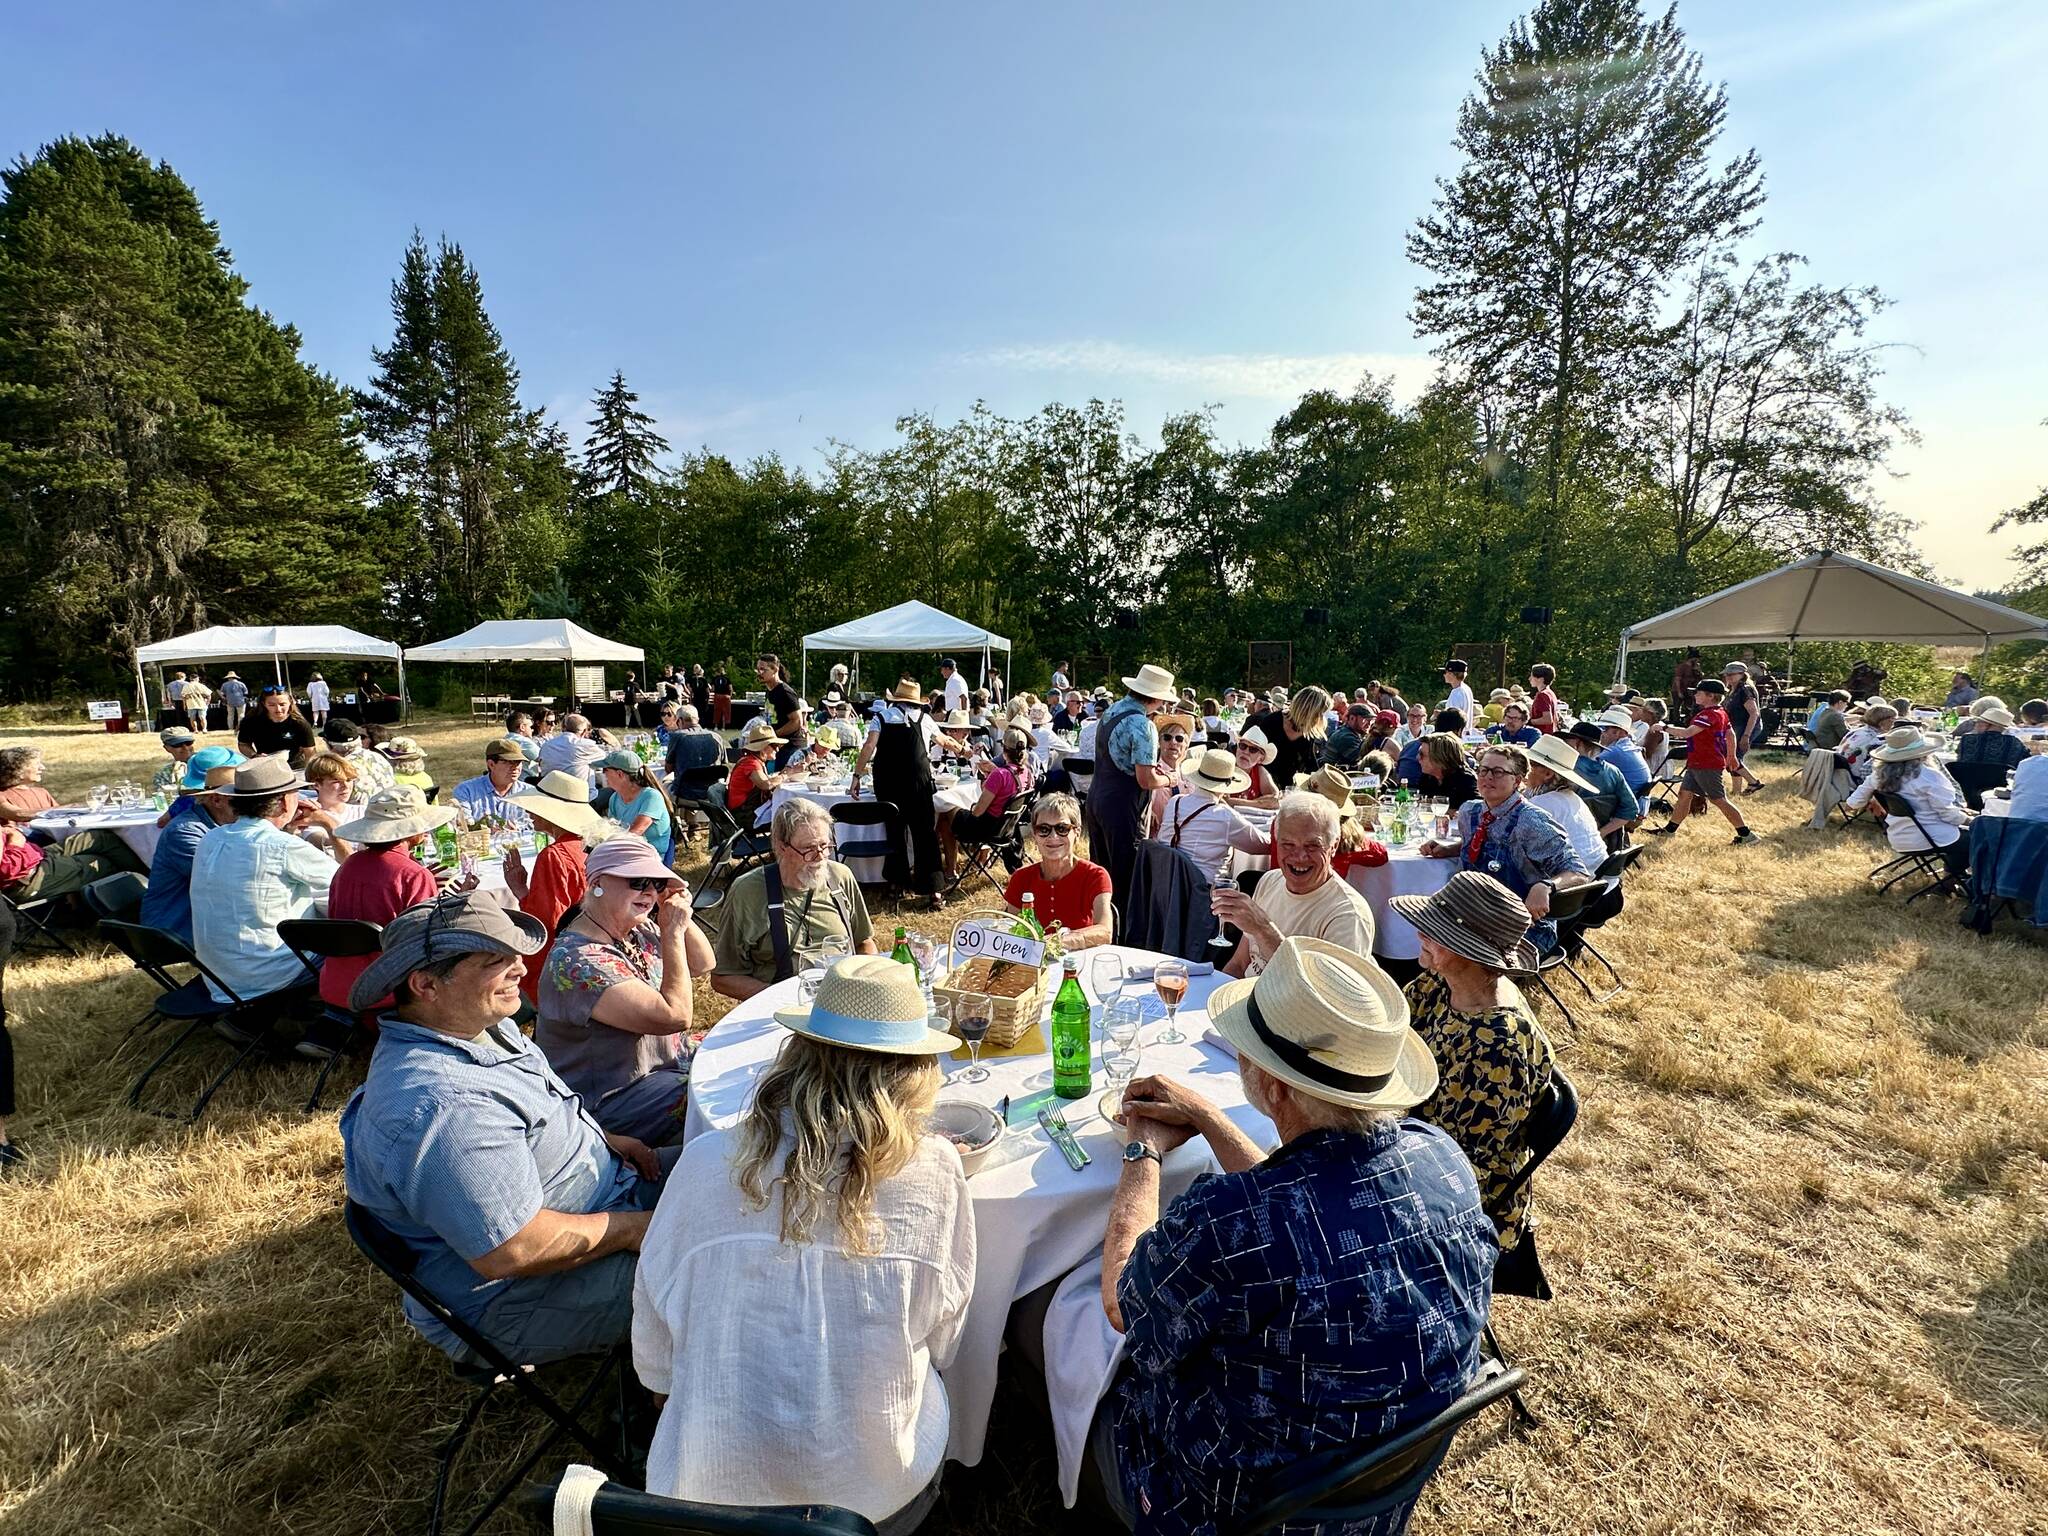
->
0;721;2048;1536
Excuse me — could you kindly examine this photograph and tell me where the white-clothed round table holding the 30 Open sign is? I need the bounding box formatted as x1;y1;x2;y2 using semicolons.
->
684;946;1278;1466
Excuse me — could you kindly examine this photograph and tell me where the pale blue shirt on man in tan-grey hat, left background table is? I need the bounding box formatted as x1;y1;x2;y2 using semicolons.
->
193;817;336;1004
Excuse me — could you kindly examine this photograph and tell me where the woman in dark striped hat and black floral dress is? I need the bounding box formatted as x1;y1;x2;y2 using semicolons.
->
1393;872;1554;1266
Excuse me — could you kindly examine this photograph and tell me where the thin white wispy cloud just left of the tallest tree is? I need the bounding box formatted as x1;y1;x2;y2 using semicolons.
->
958;340;1436;399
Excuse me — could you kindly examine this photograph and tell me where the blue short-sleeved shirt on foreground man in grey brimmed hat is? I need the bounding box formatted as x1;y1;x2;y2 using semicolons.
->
342;1016;657;1350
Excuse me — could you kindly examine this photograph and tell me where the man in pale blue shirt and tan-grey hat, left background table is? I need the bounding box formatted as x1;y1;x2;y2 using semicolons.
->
193;756;340;1004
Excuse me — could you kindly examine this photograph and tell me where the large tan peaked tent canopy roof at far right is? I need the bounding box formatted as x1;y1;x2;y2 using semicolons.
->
1622;551;2048;657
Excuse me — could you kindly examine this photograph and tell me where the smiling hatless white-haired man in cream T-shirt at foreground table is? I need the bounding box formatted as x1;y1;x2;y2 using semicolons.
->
1210;788;1372;977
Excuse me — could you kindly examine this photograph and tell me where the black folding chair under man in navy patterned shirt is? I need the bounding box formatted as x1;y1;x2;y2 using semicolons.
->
1217;1360;1524;1536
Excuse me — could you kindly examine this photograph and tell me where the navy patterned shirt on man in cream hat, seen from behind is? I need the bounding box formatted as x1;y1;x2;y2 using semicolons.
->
1114;1120;1499;1536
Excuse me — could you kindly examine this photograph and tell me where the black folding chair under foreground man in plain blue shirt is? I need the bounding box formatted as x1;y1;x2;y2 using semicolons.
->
342;1200;631;1536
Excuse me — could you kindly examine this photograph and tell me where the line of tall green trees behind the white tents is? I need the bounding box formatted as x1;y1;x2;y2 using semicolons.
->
0;0;1949;698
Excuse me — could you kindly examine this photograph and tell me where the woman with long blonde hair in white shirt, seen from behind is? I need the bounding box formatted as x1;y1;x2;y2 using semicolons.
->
633;954;975;1536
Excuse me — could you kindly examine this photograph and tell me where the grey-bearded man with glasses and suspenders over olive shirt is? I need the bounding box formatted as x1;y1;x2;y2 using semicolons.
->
711;797;877;999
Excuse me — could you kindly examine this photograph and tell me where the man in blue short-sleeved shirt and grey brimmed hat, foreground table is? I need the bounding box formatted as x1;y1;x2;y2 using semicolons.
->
342;891;674;1364
